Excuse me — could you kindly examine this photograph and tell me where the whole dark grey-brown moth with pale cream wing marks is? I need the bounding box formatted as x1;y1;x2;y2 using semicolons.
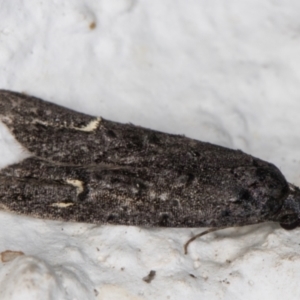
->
0;90;300;250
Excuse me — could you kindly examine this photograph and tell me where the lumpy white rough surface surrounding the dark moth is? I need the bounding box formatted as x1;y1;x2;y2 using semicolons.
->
0;0;300;300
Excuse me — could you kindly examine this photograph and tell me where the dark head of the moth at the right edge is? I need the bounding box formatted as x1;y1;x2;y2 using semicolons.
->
276;183;300;230
